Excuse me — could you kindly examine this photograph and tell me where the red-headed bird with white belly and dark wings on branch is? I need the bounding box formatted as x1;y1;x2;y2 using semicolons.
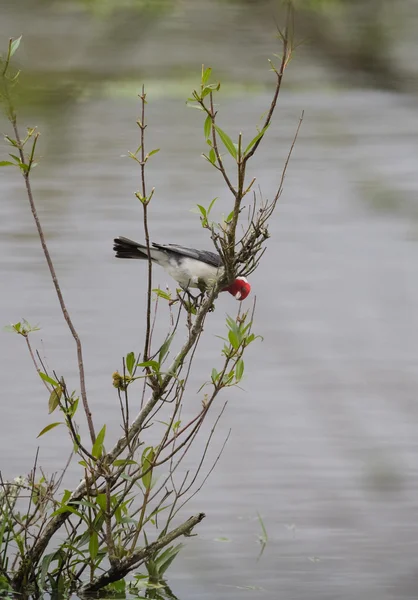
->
113;236;251;301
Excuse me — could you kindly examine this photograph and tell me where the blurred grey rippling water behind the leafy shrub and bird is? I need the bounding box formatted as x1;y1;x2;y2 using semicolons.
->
0;0;418;600
